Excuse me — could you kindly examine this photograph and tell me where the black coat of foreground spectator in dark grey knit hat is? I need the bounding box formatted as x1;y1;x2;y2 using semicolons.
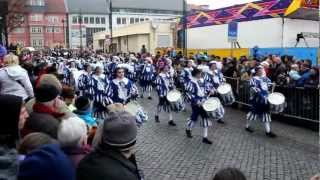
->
77;149;140;180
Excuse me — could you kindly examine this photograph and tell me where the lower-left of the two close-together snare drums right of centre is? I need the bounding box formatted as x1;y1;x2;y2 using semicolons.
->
202;97;224;120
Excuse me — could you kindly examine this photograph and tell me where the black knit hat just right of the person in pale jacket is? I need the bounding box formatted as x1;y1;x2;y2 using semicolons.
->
35;84;60;102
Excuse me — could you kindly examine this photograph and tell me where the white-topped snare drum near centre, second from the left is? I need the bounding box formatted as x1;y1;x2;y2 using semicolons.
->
167;90;185;112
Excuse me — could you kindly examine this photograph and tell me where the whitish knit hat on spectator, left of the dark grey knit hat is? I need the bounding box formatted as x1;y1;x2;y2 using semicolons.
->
58;117;87;147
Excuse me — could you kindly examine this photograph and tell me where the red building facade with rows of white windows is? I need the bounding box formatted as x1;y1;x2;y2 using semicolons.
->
8;0;67;49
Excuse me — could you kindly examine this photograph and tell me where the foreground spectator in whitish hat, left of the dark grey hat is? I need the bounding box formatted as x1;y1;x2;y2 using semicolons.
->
58;117;90;168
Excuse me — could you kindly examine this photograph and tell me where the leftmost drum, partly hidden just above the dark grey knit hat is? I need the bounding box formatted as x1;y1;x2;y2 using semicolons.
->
124;101;148;126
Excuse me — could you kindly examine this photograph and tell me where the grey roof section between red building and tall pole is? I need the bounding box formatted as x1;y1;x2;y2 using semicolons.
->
65;0;109;14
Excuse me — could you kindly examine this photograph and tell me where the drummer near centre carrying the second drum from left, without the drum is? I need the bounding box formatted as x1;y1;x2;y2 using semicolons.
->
155;66;176;126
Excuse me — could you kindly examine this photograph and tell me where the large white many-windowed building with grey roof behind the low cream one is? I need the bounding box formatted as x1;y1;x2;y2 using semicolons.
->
65;0;183;48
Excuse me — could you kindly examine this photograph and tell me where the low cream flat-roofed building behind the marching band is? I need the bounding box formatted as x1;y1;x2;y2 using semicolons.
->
93;21;176;54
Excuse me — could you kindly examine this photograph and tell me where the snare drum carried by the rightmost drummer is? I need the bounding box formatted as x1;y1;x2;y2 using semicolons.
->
268;92;286;114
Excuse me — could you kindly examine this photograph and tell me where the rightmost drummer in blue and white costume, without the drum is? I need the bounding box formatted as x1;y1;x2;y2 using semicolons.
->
246;66;276;138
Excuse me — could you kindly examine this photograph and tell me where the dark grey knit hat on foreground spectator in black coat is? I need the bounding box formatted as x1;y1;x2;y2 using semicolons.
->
102;111;137;150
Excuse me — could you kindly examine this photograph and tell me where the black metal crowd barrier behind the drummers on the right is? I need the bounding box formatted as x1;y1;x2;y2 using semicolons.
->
225;77;320;123
